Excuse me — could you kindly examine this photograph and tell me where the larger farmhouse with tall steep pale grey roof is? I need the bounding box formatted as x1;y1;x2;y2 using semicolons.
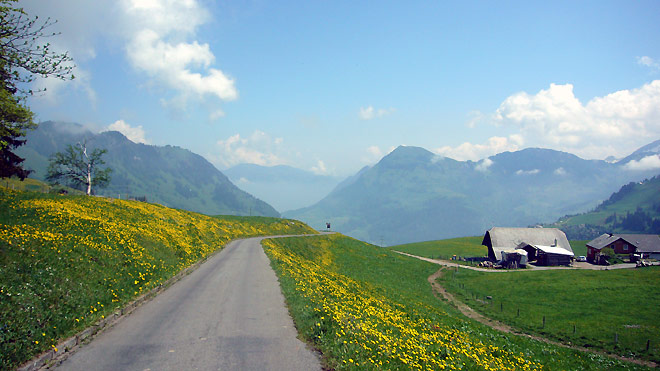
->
481;227;573;265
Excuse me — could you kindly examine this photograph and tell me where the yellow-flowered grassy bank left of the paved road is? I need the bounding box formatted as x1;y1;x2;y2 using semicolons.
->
0;187;315;370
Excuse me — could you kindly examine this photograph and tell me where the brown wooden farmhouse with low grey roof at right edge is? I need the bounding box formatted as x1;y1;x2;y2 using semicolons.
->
587;233;660;262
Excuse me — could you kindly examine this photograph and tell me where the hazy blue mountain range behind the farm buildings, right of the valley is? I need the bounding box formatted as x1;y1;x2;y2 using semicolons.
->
284;141;660;245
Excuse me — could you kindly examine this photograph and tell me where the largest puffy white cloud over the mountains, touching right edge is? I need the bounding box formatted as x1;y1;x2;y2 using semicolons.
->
493;80;660;158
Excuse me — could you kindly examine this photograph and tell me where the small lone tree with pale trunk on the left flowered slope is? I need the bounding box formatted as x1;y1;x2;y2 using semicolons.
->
46;142;112;195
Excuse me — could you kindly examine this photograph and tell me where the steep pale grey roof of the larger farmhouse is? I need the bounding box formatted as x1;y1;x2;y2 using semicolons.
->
481;227;573;261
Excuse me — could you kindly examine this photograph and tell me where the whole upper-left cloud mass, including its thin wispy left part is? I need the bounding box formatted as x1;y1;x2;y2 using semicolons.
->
20;0;238;115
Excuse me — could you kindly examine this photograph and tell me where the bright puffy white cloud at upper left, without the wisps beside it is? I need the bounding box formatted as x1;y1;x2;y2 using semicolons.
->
121;0;238;108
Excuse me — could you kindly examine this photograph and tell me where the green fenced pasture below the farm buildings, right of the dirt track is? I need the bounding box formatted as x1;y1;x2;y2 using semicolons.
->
440;267;660;362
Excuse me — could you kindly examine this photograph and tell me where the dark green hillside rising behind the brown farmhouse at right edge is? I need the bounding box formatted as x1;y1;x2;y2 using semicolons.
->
547;176;660;240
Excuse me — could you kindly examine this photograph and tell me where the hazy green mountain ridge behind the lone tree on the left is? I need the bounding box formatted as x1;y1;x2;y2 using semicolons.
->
16;121;280;216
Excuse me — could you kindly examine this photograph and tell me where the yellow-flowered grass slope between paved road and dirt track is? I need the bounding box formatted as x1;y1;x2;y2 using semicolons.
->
263;234;646;370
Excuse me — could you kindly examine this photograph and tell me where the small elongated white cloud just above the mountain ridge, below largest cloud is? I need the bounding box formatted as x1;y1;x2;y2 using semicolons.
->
434;135;523;161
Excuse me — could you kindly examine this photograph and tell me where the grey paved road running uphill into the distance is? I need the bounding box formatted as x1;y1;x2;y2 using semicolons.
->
59;238;321;371
